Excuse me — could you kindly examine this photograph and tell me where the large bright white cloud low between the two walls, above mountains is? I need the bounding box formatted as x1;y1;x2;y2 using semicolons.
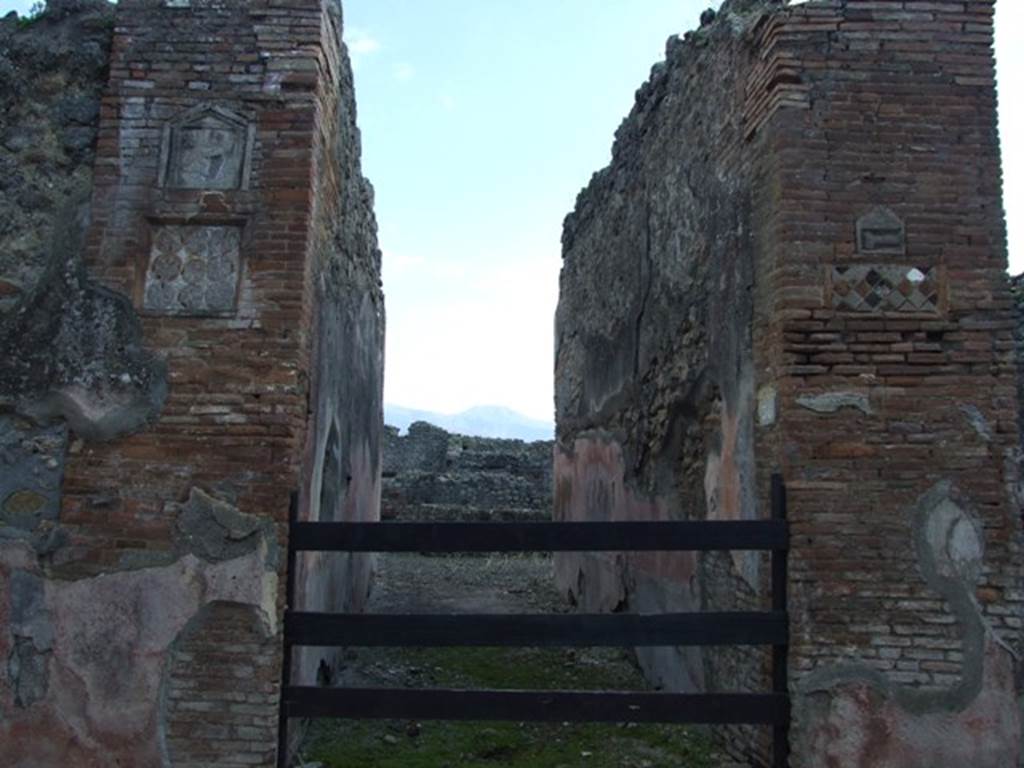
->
384;246;560;419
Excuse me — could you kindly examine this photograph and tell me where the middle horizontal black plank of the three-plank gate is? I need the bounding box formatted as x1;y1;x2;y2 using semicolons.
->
285;611;787;647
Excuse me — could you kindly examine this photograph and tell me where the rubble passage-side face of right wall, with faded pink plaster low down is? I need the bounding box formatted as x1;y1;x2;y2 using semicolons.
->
554;6;764;754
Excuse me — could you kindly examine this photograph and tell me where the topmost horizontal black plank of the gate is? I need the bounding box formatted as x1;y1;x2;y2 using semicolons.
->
290;520;788;552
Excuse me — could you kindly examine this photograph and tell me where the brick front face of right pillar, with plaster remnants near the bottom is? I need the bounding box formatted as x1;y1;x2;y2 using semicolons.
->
760;0;1022;766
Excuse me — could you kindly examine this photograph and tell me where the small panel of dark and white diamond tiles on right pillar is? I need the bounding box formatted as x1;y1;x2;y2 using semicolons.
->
829;264;941;314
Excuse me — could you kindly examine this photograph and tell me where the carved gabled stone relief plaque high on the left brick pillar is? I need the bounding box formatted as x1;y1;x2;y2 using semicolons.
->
159;104;255;189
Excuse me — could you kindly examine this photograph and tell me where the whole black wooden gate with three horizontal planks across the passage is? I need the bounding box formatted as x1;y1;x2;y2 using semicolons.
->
279;475;790;768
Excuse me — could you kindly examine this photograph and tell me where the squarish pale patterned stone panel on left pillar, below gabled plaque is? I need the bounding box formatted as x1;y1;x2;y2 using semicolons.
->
142;226;242;315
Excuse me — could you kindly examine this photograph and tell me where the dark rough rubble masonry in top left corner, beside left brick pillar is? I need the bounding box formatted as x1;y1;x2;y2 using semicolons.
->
0;0;114;321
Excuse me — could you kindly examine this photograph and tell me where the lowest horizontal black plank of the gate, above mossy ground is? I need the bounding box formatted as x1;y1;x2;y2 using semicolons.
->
283;686;787;724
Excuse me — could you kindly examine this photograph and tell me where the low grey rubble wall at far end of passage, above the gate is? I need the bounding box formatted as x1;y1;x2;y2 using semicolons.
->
381;422;553;520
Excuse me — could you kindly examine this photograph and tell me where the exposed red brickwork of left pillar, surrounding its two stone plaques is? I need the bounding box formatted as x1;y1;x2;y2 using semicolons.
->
62;0;322;570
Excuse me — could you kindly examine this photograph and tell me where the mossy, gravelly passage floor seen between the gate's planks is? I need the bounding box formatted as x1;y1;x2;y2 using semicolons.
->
301;555;721;768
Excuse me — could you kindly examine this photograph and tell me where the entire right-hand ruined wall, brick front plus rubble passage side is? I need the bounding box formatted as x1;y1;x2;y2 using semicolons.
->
554;0;1022;768
